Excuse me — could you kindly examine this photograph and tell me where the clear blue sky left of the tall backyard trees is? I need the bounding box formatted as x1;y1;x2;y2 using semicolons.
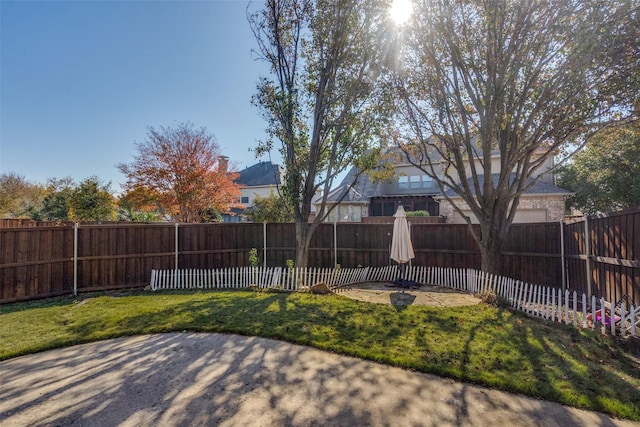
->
0;0;278;192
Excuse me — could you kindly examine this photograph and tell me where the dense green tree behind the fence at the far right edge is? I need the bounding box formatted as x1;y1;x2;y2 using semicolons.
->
560;122;640;214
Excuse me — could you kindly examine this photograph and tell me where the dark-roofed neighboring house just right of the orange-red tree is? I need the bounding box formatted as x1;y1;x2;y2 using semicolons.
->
224;162;283;222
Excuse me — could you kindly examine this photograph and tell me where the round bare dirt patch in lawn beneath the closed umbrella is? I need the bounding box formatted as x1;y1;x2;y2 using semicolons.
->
334;282;480;307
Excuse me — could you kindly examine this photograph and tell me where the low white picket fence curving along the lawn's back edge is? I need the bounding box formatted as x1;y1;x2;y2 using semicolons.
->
151;266;640;337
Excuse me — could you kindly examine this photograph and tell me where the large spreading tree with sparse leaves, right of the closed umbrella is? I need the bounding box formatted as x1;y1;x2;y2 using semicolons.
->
398;0;638;272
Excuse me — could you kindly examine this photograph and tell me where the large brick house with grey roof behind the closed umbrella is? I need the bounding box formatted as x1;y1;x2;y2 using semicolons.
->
316;148;571;223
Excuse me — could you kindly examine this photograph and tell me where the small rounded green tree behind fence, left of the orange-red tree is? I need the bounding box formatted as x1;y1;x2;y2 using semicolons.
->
69;176;116;221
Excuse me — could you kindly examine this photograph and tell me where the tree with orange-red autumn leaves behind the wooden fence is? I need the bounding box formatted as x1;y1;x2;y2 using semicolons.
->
118;123;240;222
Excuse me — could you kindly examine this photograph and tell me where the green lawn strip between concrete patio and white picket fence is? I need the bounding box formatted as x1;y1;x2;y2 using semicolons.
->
0;291;640;420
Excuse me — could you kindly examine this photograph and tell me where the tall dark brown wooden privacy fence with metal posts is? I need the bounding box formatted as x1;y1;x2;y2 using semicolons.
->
0;209;640;304
